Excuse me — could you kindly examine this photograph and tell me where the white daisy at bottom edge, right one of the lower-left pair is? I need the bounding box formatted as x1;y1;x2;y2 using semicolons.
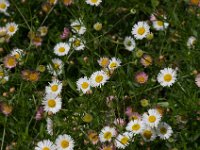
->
55;134;74;150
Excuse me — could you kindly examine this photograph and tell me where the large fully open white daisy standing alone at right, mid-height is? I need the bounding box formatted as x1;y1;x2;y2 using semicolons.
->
157;68;177;87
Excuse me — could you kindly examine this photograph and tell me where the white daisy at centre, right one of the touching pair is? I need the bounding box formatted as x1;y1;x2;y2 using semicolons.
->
90;70;109;87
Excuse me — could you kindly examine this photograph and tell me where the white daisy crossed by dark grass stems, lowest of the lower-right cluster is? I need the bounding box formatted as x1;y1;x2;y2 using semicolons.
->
115;132;133;149
